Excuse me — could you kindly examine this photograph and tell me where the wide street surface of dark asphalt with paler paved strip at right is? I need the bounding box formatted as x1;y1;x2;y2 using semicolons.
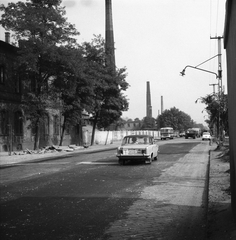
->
0;139;209;240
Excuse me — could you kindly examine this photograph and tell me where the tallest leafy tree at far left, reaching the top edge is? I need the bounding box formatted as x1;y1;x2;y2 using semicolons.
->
0;0;79;149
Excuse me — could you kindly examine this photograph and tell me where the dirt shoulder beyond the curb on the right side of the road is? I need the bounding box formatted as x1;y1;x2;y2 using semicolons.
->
208;147;236;240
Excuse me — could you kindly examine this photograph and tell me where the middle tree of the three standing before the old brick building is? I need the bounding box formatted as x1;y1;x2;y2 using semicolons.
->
52;47;89;145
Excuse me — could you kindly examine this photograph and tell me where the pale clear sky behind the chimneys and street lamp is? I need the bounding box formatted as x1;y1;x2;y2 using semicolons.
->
0;0;227;125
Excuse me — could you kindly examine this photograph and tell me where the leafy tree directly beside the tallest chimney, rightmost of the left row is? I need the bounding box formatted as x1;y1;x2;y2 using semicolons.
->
82;35;129;145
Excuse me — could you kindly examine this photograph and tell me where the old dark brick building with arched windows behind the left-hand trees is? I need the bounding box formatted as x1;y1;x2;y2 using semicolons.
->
0;33;90;152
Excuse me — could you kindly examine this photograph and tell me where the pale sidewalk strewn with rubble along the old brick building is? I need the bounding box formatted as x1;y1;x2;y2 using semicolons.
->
0;141;121;166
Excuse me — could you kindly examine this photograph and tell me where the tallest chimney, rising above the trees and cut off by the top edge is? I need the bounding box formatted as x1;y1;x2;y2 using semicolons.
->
105;0;116;72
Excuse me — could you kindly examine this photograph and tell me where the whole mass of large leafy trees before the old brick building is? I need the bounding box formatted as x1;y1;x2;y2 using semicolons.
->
0;0;128;148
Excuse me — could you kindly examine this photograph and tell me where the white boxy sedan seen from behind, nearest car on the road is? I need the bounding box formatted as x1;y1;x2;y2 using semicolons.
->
116;135;159;165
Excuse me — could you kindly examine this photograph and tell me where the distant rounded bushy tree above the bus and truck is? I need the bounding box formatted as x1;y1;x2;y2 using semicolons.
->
157;107;194;131
